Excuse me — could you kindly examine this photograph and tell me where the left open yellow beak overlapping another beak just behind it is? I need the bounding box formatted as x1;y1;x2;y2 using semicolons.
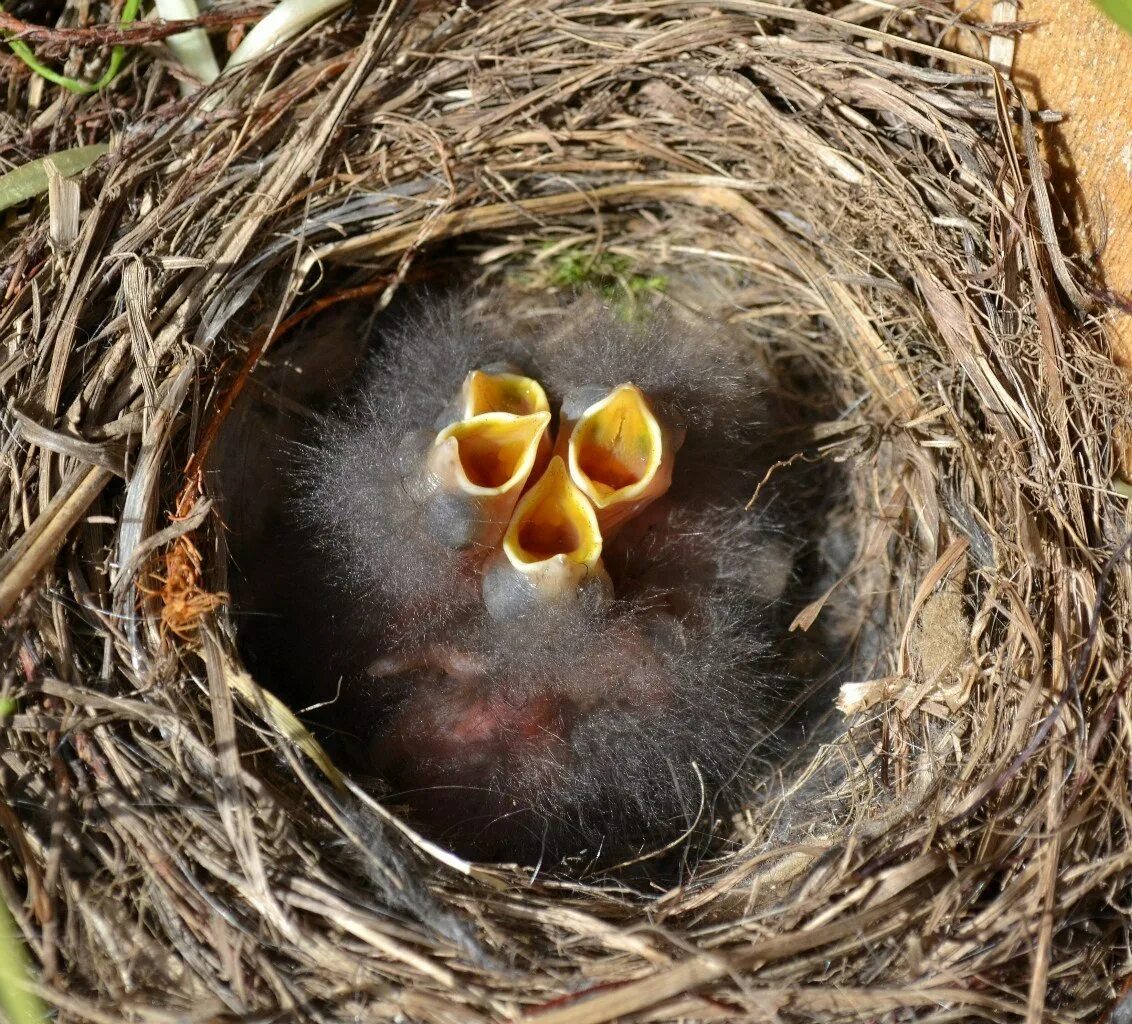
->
426;411;550;545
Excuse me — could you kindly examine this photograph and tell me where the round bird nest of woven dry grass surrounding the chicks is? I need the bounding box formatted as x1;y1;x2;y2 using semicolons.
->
0;0;1132;1024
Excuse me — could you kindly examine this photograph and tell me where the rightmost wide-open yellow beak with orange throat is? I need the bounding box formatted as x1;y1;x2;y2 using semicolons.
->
566;384;684;536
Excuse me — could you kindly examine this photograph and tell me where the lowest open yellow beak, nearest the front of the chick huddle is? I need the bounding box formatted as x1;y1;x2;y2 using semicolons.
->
483;456;611;618
